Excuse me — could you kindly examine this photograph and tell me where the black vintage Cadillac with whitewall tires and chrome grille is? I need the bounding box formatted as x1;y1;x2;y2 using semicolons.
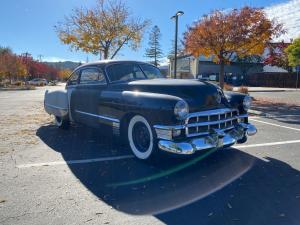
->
44;61;256;160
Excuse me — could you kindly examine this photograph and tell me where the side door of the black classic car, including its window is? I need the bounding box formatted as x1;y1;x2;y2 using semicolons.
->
71;66;107;127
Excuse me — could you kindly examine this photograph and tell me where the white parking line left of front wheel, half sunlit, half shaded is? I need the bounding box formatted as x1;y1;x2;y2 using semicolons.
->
17;155;134;169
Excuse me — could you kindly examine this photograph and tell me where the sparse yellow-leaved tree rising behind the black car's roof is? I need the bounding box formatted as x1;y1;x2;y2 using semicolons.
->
55;0;149;59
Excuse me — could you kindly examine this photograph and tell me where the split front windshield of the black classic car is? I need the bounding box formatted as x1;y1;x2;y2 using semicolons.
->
106;63;162;82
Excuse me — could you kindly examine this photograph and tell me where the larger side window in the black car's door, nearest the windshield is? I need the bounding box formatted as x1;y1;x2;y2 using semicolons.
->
80;68;106;84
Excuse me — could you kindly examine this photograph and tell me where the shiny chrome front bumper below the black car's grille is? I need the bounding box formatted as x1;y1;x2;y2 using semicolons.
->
158;123;257;155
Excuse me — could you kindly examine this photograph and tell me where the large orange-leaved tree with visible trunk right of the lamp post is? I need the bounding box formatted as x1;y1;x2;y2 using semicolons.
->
184;7;284;88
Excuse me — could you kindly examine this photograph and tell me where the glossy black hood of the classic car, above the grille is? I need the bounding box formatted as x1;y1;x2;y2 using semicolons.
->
120;79;224;112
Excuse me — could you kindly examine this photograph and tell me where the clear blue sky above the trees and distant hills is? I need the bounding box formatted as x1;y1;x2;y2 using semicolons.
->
0;0;294;61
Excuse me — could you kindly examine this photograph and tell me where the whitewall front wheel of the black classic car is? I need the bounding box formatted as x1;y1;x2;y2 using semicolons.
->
127;115;157;160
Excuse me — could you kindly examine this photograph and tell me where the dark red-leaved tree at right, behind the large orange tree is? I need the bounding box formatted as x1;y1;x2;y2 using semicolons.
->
264;42;292;72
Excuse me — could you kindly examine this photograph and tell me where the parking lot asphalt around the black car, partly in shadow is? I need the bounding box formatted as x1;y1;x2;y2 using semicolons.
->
0;86;300;225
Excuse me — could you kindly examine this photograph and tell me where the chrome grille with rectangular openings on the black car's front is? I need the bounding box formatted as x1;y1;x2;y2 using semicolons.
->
186;108;239;137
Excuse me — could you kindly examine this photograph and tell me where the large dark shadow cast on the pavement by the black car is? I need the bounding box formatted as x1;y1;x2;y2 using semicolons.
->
37;125;300;225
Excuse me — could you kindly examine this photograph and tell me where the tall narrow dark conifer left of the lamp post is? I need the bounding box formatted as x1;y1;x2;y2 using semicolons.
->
145;26;163;66
